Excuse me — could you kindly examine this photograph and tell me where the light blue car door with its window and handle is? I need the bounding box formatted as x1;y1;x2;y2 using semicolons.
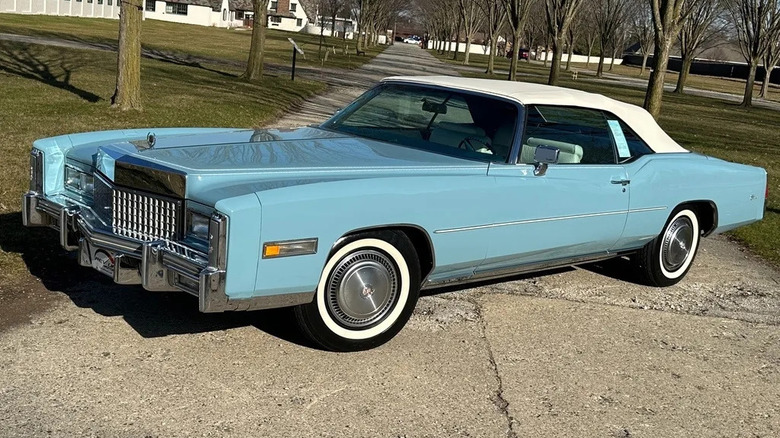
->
477;106;630;272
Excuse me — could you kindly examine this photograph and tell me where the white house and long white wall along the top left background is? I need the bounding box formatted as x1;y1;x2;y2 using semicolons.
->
0;0;314;32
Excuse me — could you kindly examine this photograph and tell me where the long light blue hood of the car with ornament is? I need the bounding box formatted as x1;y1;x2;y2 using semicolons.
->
67;127;488;203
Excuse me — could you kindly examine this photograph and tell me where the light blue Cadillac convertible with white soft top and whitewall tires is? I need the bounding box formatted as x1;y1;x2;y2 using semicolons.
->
23;77;766;351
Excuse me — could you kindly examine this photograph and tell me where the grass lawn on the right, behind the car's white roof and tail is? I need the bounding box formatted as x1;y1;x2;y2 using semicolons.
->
435;49;780;266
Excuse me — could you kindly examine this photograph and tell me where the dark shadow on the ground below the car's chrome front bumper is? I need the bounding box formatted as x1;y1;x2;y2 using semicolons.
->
0;212;312;347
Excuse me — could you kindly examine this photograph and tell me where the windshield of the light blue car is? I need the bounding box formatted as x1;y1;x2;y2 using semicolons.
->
322;84;517;162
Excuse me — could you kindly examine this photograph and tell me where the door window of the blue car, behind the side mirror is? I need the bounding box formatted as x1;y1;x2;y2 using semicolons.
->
520;105;617;164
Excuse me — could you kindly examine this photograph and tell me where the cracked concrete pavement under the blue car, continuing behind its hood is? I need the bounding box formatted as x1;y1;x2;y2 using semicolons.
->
0;44;780;437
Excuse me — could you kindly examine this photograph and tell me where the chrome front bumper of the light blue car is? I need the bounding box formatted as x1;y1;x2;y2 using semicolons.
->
22;192;232;312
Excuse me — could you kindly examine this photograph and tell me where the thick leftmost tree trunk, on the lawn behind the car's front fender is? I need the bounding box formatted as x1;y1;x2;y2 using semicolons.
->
111;0;142;111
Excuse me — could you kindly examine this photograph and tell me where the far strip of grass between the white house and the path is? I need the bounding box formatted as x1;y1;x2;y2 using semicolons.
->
0;13;385;69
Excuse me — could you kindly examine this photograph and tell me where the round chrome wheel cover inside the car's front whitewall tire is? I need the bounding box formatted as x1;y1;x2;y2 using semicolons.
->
325;250;400;328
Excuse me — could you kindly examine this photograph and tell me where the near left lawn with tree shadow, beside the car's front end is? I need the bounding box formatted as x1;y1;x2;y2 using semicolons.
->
0;41;325;285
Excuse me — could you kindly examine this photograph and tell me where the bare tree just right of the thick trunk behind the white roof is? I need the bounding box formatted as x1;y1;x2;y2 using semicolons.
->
674;0;723;93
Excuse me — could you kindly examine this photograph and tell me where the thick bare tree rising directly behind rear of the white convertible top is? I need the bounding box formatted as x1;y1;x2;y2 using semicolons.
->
644;0;688;118
